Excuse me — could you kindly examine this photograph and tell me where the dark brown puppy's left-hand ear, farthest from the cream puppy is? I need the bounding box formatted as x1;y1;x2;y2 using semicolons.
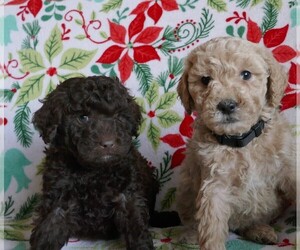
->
32;89;67;144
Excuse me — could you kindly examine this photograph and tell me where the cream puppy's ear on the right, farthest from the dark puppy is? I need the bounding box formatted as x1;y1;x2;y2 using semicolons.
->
262;51;288;108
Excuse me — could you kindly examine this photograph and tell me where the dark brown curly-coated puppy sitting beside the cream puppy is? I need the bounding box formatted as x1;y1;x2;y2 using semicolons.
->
30;76;159;250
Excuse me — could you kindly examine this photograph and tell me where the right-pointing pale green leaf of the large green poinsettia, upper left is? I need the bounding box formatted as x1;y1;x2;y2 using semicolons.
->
59;48;97;70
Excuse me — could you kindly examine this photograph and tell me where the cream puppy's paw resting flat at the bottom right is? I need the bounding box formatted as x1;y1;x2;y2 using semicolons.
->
243;224;278;245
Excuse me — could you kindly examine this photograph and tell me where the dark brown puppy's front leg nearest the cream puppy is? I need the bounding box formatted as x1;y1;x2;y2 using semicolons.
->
115;197;154;250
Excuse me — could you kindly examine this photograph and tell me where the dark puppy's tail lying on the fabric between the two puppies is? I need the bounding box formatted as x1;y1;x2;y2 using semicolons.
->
149;211;181;228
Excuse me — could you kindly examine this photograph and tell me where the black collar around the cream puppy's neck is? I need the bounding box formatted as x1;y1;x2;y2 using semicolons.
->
215;120;265;148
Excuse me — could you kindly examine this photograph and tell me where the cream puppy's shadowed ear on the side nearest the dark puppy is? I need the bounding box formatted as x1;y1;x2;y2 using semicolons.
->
177;71;195;114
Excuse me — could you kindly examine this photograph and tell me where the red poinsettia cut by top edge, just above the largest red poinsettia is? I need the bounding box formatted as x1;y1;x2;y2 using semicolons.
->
130;0;178;24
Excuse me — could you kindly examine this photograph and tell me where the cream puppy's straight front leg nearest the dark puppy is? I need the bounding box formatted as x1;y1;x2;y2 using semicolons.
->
196;181;230;250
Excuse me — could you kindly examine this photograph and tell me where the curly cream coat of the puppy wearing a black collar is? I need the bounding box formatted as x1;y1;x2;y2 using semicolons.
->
177;37;296;250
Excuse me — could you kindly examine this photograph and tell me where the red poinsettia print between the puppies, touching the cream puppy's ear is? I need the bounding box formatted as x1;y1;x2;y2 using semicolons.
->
160;114;194;168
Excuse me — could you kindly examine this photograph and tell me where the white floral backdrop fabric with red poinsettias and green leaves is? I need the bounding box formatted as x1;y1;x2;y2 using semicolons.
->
0;0;300;249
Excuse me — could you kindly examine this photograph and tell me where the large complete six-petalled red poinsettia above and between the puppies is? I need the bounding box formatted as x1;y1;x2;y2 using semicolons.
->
97;13;163;82
